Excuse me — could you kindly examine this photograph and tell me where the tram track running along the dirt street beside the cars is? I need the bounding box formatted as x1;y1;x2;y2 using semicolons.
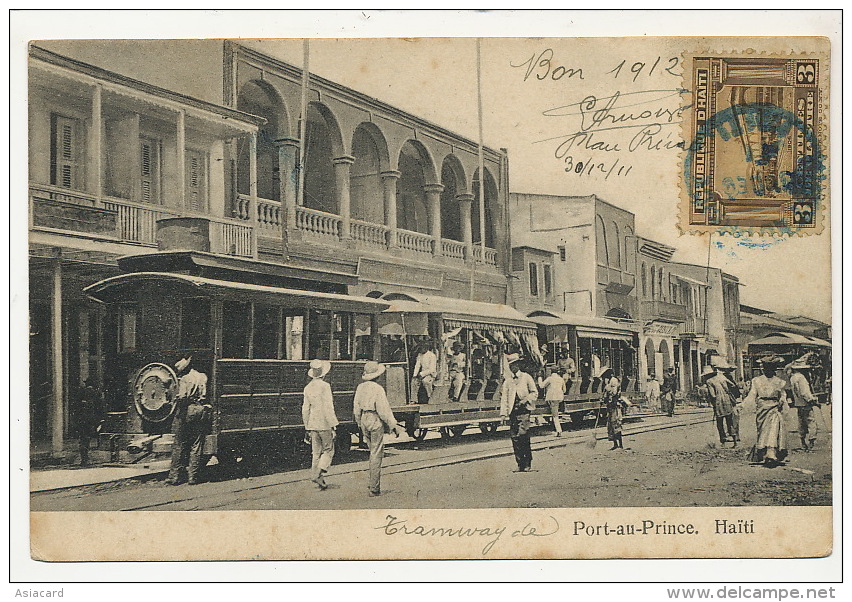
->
86;411;713;511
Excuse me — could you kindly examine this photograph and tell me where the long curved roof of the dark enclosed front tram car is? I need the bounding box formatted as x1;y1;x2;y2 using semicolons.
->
84;272;390;313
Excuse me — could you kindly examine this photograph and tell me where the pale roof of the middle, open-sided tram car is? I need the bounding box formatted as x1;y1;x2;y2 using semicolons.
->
386;294;535;330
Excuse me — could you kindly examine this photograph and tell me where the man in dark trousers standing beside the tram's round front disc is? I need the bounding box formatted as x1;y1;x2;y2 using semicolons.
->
166;357;213;485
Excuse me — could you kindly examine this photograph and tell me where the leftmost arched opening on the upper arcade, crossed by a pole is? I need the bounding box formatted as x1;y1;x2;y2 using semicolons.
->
237;81;287;201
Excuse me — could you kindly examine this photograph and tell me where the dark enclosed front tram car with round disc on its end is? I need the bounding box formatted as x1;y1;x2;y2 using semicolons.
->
86;271;418;464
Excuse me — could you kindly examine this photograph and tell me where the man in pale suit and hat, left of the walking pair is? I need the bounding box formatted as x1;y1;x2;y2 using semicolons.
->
302;360;338;490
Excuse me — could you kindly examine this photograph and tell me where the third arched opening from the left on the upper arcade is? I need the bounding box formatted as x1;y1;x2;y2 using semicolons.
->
349;124;387;224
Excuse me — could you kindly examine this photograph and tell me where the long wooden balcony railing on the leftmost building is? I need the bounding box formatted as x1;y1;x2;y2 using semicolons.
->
30;184;254;257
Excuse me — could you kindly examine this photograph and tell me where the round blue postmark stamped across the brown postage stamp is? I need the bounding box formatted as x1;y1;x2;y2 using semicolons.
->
683;103;826;236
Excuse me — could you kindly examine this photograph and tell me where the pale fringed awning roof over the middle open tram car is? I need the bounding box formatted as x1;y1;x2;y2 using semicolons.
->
383;295;536;334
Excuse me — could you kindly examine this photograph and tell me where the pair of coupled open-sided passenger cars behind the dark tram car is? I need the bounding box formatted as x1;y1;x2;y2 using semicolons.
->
379;293;638;440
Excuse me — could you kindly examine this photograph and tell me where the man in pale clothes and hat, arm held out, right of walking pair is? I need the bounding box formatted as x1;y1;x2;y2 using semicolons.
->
353;361;400;497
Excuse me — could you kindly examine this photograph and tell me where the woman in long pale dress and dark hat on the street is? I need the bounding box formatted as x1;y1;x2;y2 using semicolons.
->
746;356;787;468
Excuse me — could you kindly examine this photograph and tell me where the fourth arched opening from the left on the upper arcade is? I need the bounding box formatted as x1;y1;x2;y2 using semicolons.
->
396;140;432;234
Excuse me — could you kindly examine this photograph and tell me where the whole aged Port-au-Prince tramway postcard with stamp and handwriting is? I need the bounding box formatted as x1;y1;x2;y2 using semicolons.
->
15;12;840;576
